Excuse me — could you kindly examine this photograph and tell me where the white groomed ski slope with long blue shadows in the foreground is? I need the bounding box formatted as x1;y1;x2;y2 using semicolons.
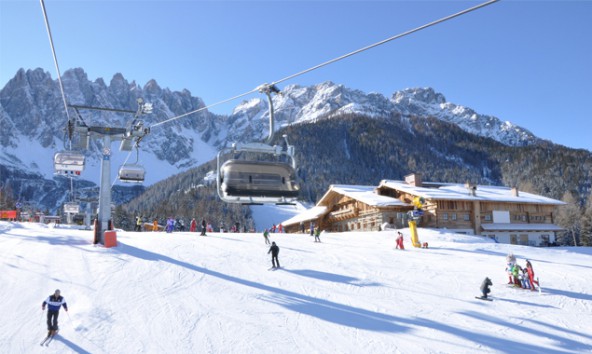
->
0;209;592;354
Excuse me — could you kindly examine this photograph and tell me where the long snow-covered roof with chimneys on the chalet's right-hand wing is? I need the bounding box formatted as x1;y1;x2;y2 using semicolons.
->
380;180;565;205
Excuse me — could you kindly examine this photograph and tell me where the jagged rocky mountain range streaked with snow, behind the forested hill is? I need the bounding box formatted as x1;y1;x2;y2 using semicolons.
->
0;68;539;212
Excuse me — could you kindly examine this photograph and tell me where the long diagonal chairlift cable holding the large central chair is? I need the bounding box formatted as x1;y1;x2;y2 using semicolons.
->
149;0;500;128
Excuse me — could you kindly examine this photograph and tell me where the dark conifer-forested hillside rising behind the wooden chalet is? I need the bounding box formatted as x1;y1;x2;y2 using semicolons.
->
120;115;592;244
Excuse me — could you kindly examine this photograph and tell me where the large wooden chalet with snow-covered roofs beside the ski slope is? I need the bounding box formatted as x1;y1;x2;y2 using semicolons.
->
283;174;565;246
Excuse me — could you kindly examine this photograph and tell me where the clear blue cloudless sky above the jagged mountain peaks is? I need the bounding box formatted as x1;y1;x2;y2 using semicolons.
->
0;0;592;150
